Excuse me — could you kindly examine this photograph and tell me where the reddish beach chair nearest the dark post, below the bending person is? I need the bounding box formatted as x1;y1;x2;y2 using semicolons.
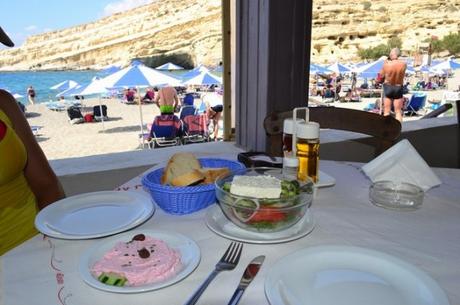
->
182;114;209;144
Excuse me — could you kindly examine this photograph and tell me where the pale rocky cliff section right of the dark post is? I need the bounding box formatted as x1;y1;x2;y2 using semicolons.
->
311;0;460;62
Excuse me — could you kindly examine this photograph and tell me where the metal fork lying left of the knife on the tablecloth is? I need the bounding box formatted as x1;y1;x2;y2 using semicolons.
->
184;242;243;305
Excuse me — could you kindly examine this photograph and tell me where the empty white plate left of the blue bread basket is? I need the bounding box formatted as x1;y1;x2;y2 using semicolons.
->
35;191;155;239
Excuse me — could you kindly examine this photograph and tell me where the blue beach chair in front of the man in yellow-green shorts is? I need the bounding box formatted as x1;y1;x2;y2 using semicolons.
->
148;114;182;148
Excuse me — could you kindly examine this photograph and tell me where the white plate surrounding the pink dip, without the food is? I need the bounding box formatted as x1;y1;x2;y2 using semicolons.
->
79;230;200;293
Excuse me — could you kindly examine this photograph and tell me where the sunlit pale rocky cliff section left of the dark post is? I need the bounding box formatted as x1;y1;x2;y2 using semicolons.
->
0;0;222;70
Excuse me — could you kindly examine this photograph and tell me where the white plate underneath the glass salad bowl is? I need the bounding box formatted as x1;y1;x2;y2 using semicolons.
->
205;204;315;244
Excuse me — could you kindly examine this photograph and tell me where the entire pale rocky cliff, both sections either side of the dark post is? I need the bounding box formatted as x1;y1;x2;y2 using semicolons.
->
0;0;460;70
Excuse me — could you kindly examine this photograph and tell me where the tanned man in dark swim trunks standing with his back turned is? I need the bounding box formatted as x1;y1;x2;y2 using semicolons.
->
380;48;406;122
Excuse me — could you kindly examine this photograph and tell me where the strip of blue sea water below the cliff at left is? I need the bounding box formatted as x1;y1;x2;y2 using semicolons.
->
0;70;100;105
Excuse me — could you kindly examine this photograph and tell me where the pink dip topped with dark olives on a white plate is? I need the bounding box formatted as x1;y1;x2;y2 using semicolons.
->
91;234;181;286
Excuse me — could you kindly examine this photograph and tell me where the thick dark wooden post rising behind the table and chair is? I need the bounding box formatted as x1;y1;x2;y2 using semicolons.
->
234;0;312;151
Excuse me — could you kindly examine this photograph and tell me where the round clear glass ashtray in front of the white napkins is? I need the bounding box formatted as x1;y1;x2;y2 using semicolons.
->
369;181;425;211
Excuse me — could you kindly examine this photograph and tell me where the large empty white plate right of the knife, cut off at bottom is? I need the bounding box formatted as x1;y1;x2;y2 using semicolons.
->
265;246;449;305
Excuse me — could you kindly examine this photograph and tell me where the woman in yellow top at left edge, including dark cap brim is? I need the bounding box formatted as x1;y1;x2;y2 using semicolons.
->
0;28;64;255
